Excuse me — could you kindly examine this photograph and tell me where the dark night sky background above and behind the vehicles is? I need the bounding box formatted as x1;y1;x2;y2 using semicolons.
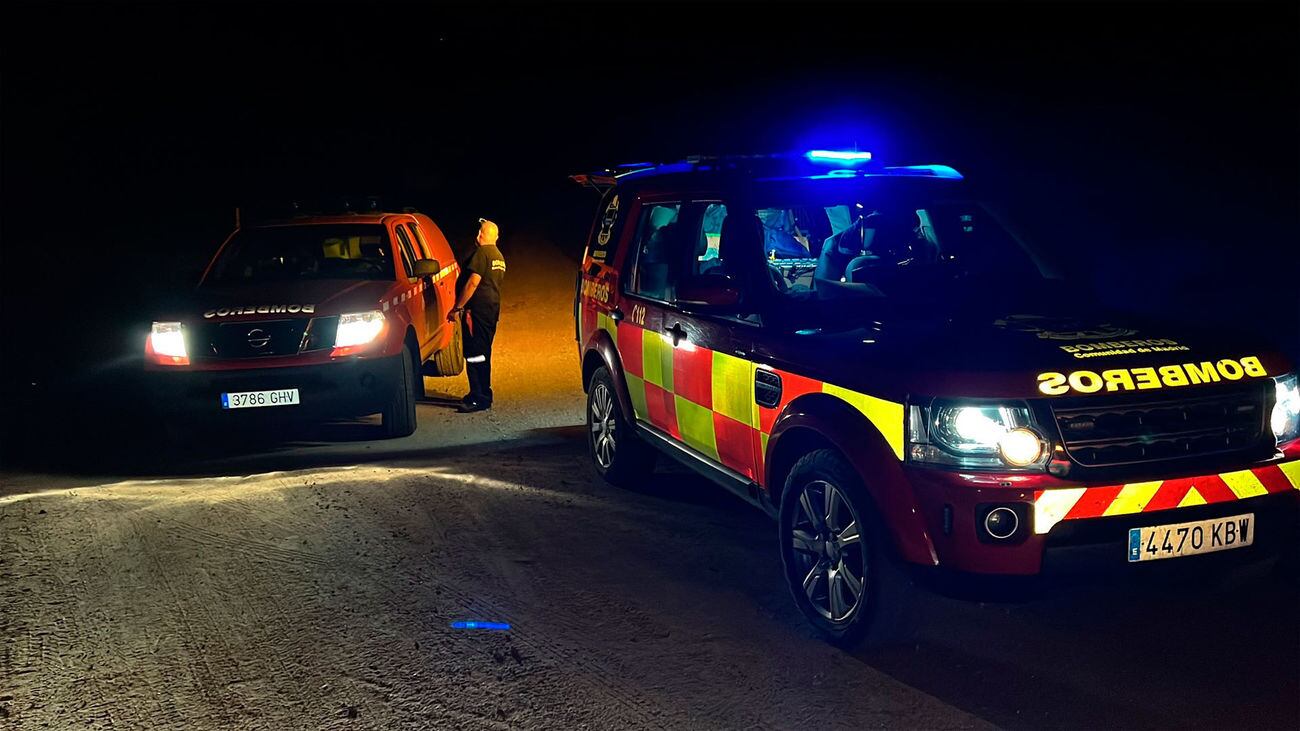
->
0;3;1300;393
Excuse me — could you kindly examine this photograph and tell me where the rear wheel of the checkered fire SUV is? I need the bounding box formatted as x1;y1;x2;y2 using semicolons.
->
586;366;655;486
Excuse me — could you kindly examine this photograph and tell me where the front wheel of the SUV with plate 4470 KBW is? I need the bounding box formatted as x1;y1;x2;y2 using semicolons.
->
779;449;917;646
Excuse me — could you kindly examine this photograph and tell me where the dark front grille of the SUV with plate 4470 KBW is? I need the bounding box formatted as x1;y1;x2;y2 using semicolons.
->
1052;382;1268;467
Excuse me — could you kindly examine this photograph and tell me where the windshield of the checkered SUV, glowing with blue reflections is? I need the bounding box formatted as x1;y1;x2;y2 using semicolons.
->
755;181;1043;302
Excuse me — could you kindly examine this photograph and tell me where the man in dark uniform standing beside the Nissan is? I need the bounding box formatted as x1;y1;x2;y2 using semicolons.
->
447;219;506;414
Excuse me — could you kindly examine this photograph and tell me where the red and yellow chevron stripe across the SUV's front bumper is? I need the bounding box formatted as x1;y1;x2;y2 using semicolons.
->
1034;460;1300;535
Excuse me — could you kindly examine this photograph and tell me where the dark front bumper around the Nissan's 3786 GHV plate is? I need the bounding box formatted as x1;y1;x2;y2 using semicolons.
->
147;355;402;425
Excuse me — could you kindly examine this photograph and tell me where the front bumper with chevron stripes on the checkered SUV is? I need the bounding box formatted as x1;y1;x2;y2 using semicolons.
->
907;454;1300;576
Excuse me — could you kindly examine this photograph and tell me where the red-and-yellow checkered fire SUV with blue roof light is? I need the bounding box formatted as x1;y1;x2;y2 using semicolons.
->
575;151;1300;643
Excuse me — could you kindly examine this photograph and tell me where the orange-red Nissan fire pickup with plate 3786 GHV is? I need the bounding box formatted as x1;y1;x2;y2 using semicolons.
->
146;208;464;437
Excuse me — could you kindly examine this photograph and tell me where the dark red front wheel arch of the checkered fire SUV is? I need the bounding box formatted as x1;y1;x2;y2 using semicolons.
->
763;393;937;566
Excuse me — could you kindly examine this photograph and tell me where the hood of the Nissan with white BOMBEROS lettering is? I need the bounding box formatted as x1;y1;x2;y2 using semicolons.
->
162;280;393;321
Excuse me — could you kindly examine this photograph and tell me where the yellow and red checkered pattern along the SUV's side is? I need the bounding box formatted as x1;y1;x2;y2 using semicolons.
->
597;313;904;484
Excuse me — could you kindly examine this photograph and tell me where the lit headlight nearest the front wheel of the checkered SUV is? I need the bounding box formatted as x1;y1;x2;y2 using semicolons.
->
907;399;1048;471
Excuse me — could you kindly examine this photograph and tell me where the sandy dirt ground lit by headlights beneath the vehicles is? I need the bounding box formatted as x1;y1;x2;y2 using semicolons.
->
0;238;1300;730
